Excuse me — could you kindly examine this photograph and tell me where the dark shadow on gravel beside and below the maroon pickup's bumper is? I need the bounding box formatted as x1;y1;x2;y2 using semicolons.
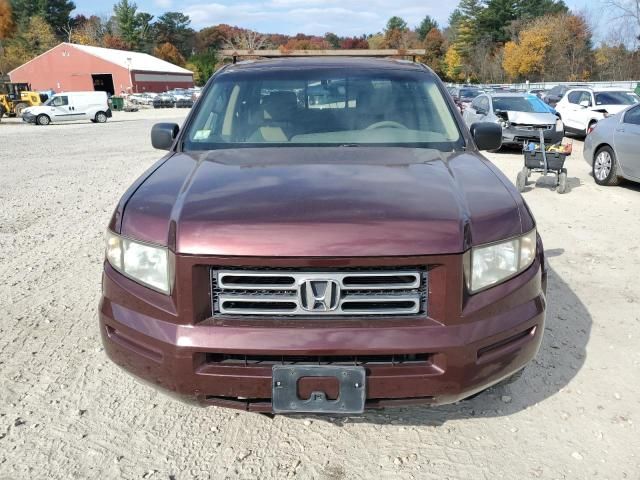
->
315;268;592;426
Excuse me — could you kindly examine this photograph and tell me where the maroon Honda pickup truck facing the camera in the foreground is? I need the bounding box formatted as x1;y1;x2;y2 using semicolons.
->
99;58;546;414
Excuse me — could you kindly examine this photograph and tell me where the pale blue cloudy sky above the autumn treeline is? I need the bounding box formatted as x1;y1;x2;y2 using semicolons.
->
74;0;597;36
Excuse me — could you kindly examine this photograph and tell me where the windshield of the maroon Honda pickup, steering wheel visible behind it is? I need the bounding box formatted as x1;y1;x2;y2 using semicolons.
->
183;68;464;151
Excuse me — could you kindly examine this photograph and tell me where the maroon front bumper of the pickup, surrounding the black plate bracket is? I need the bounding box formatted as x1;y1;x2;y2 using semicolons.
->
99;260;546;412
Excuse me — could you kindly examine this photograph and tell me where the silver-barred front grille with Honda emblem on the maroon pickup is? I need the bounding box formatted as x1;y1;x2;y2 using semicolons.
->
211;268;428;317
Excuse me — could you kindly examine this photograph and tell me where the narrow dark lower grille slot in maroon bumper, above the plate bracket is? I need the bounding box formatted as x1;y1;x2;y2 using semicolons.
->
205;353;431;367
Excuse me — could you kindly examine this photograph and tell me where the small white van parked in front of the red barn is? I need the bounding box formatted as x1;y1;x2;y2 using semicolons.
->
22;92;111;125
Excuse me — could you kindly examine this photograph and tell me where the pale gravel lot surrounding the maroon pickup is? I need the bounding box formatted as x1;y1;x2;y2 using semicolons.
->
0;109;640;480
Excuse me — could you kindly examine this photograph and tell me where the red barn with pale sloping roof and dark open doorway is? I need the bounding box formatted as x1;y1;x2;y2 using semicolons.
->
9;43;193;94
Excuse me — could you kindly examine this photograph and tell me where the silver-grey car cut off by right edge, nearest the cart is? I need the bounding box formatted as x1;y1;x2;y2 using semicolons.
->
583;105;640;185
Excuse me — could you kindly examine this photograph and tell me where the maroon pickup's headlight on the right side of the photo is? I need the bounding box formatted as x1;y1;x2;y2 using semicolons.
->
464;228;536;293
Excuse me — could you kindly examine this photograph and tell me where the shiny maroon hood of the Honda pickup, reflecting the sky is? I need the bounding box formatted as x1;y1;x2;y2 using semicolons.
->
121;147;533;256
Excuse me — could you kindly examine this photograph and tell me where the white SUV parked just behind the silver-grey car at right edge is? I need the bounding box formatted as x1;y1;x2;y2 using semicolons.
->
556;88;640;135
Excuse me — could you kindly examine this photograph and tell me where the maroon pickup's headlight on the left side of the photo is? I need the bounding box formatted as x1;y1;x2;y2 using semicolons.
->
106;230;172;294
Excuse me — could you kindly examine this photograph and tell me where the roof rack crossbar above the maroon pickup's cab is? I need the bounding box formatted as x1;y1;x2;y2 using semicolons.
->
220;48;426;63
